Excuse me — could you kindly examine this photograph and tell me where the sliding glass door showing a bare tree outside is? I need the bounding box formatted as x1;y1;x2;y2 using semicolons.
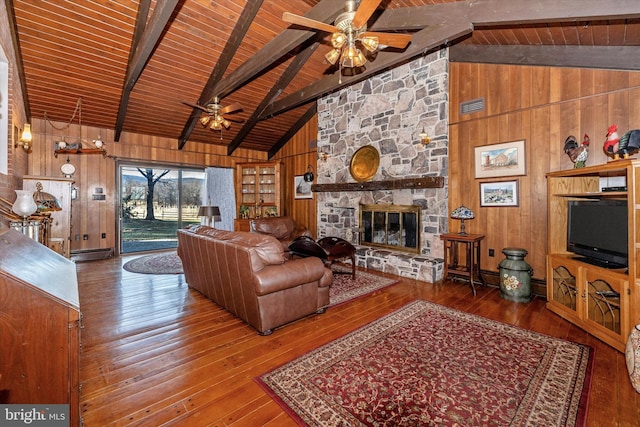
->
118;163;205;254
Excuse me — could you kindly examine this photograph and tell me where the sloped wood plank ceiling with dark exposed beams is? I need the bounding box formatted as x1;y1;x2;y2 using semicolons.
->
5;0;640;155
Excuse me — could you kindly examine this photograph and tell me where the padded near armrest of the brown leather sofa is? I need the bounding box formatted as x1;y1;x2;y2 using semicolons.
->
253;257;332;295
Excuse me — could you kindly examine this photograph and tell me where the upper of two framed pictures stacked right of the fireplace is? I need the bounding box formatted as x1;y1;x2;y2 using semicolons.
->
474;139;526;178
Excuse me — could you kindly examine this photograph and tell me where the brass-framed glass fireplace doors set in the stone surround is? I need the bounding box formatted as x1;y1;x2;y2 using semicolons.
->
360;205;420;253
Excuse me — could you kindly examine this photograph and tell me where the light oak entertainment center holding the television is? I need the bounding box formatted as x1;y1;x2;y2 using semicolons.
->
547;159;640;351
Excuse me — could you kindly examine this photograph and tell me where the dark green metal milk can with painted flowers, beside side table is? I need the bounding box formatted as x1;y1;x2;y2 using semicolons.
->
498;248;533;302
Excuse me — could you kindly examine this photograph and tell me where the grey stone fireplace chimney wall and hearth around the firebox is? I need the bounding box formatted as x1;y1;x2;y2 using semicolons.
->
316;49;449;283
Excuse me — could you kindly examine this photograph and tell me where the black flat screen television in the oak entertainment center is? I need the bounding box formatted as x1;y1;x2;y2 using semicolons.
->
567;199;629;268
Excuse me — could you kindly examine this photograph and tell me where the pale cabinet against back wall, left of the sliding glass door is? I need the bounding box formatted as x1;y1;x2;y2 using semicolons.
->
22;176;73;258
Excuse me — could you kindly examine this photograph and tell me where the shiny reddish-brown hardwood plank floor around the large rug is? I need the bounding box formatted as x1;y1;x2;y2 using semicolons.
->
77;257;640;427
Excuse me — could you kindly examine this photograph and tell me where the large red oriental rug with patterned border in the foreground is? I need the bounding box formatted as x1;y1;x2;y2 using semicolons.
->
256;301;593;426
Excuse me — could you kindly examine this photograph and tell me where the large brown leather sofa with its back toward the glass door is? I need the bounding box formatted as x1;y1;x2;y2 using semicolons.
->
178;225;333;335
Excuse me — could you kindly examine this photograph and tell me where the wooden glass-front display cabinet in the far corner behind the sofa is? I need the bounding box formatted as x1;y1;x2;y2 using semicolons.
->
235;162;282;231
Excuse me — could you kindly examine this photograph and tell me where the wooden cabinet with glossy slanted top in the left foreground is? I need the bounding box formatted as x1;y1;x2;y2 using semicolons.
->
0;230;81;426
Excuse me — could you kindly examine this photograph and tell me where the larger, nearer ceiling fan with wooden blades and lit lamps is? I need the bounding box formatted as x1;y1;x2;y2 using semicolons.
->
282;0;411;68
